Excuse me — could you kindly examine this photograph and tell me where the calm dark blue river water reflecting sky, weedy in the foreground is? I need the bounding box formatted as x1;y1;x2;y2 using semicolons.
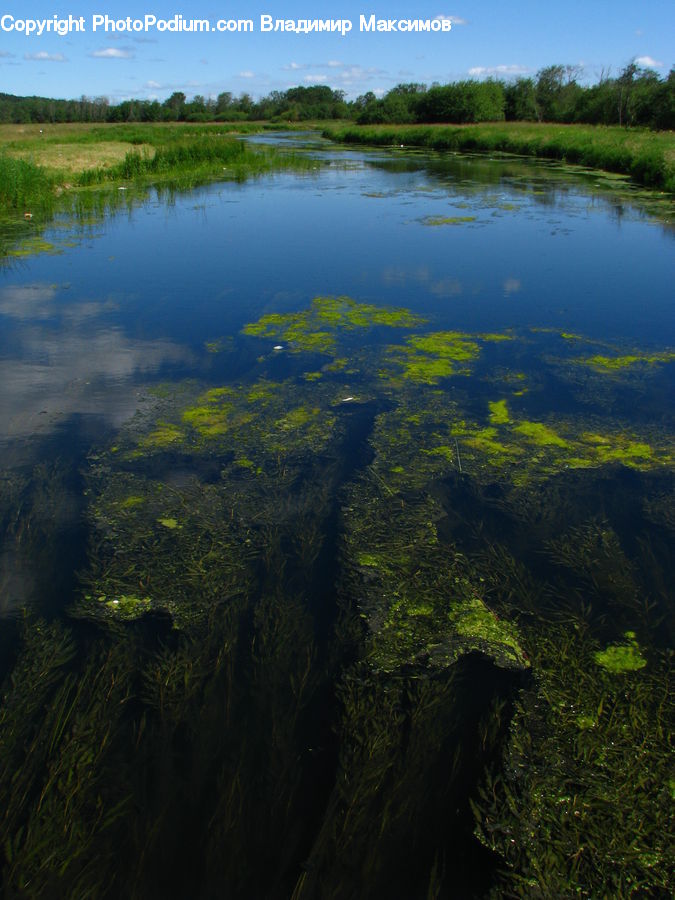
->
0;138;675;897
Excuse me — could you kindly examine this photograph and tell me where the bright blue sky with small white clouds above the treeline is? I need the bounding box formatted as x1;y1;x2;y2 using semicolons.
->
0;0;675;102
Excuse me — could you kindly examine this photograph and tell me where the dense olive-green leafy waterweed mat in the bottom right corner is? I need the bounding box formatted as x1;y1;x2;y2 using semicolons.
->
474;528;672;897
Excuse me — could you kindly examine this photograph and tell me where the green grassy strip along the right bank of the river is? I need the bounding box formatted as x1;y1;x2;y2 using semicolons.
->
323;122;675;193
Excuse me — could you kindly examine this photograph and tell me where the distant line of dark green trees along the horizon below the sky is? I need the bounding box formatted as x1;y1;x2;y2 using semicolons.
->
0;62;675;130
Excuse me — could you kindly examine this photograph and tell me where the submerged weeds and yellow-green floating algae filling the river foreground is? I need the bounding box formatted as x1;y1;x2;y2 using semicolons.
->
0;262;673;900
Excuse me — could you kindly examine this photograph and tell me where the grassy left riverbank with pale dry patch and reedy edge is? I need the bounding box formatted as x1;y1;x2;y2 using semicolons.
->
0;123;318;259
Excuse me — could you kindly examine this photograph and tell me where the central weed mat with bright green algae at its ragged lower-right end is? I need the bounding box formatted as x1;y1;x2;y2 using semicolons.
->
346;473;527;672
